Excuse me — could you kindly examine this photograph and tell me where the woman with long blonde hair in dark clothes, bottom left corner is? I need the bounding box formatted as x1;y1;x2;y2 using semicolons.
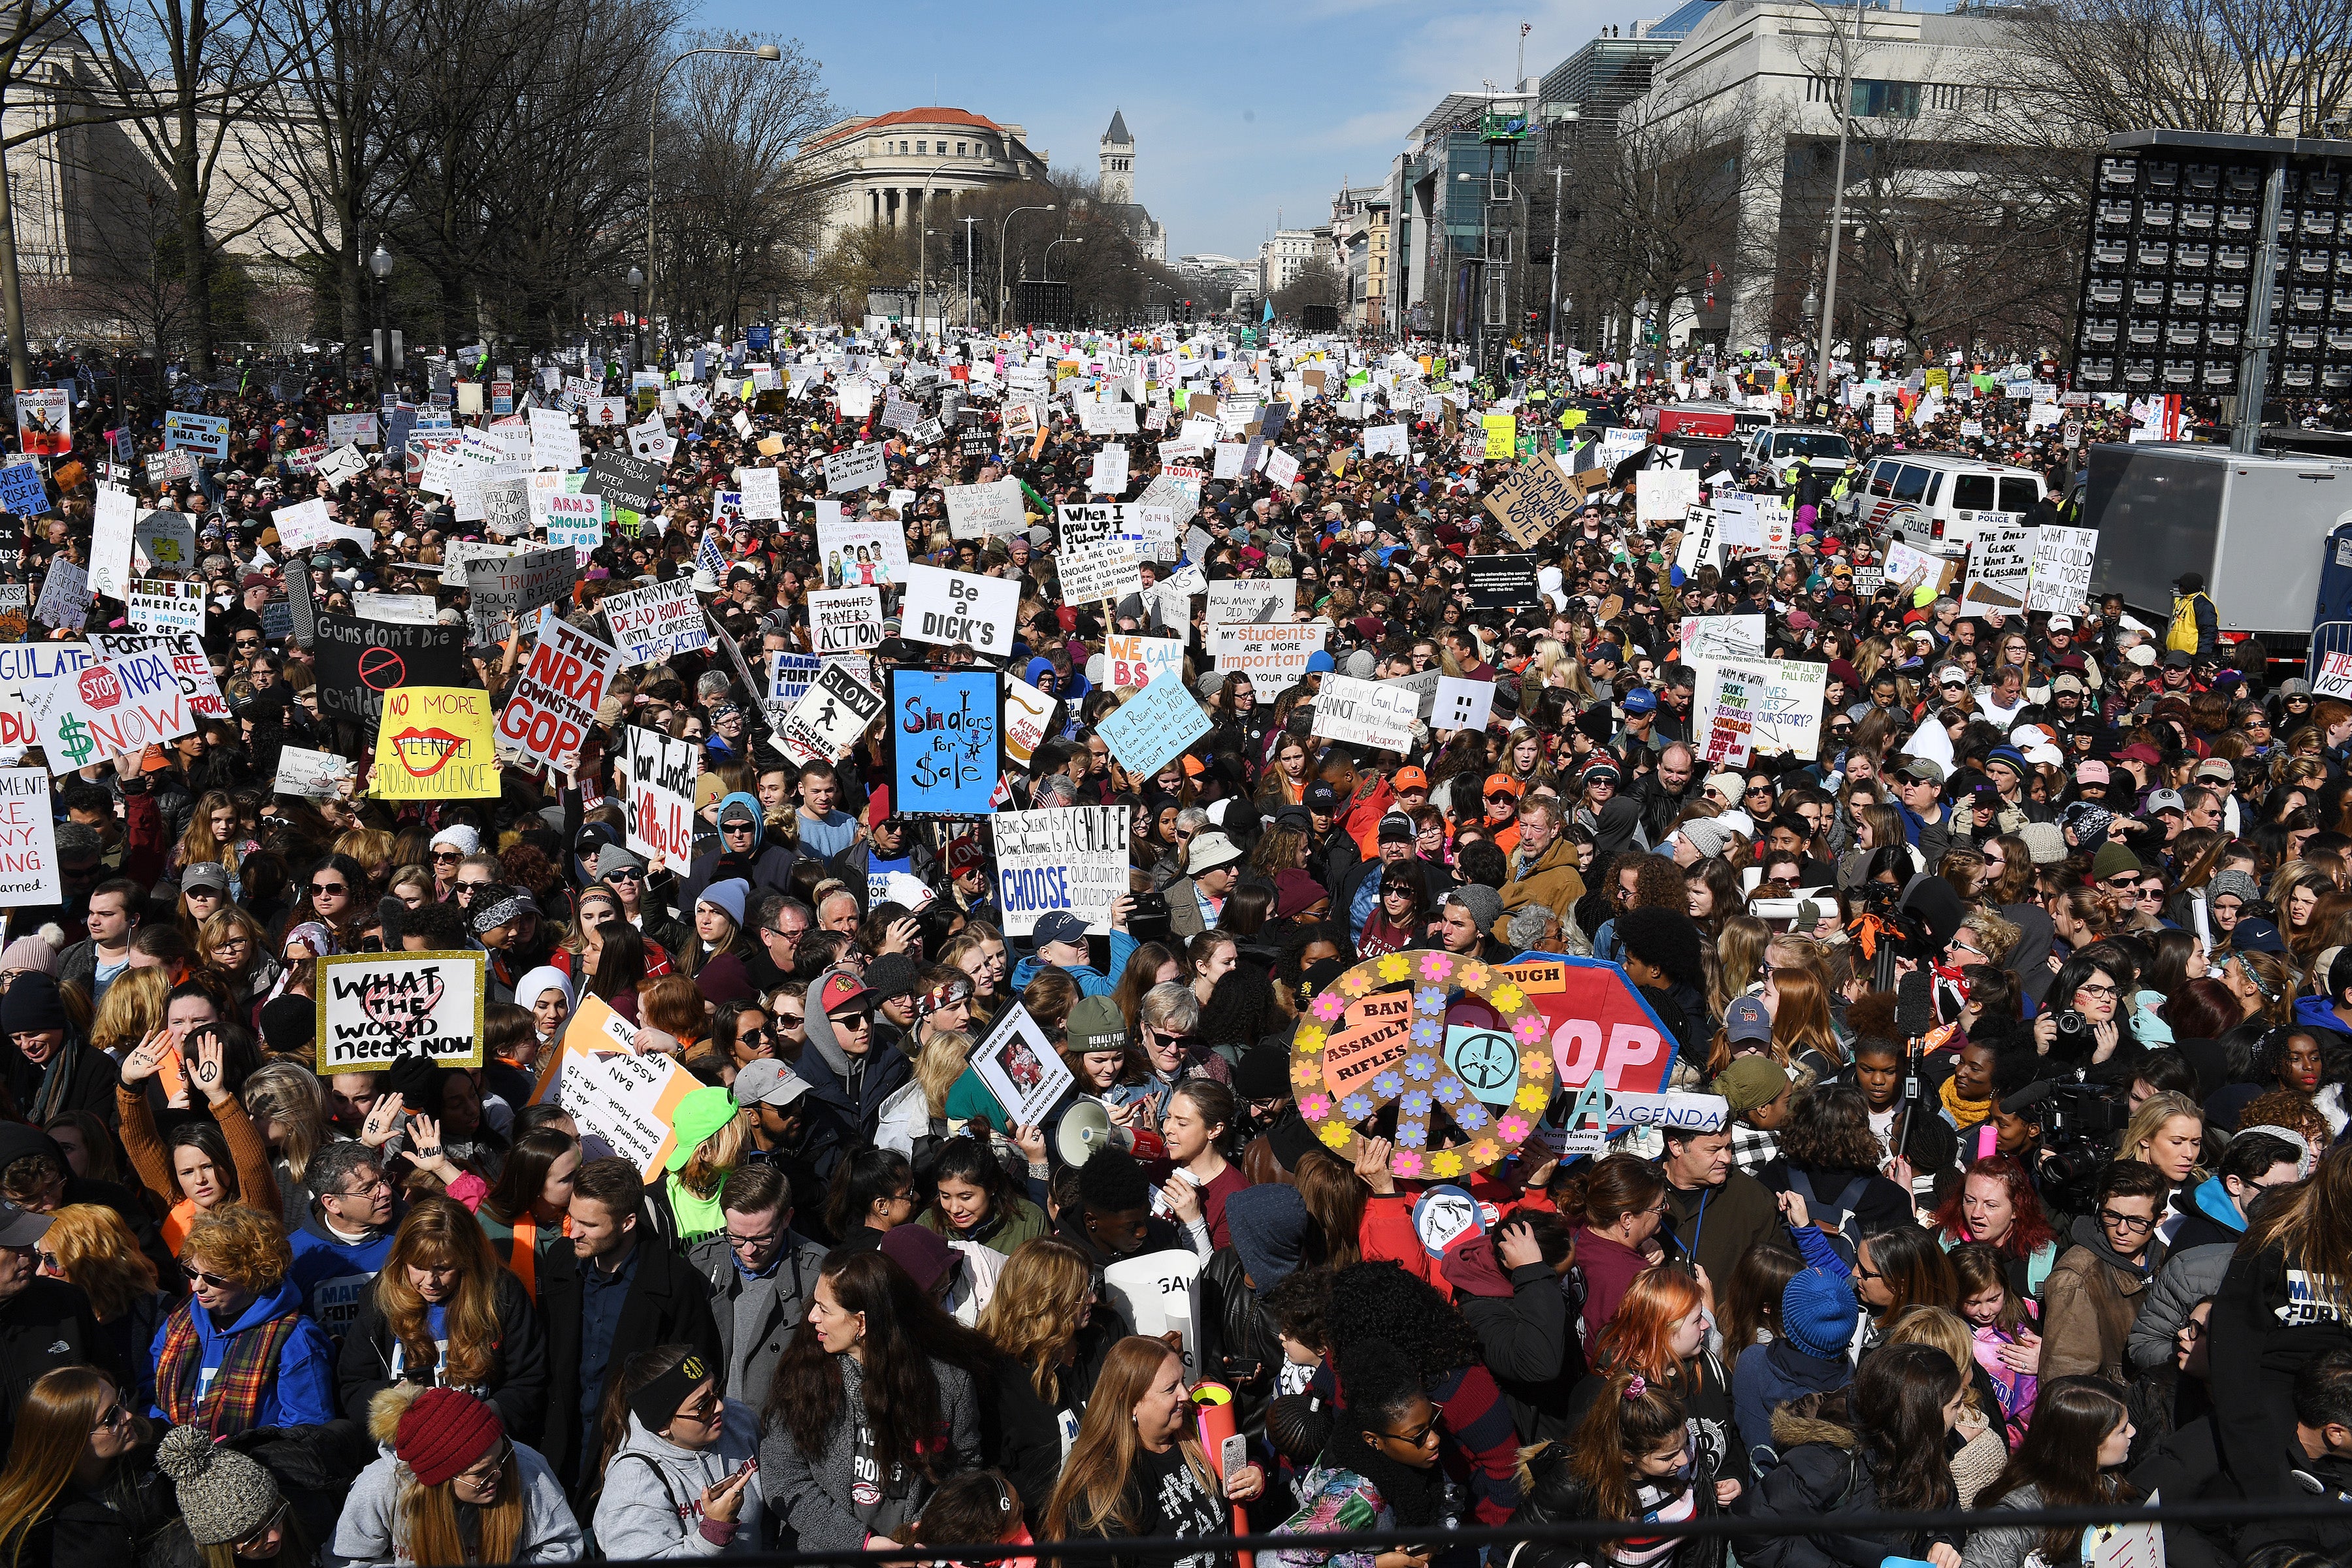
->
0;1366;174;1568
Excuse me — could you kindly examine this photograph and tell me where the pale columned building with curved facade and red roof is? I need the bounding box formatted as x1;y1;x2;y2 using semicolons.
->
795;106;1049;244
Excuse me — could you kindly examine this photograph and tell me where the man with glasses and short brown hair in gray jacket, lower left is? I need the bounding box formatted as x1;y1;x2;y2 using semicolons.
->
687;1109;826;1411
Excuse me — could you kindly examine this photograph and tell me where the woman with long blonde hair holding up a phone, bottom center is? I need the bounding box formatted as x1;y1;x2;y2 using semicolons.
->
1044;1335;1266;1540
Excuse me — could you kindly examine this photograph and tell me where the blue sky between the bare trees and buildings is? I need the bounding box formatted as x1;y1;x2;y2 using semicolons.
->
696;0;1673;259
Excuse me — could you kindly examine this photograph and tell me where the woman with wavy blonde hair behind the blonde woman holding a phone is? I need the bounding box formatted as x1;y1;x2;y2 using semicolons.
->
979;1237;1094;1514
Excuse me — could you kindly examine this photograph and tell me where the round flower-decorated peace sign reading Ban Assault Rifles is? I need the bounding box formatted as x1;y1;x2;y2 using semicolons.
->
1291;950;1555;1180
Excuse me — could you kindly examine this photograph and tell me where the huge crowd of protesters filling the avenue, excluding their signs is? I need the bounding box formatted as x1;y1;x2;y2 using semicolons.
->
0;331;2352;1568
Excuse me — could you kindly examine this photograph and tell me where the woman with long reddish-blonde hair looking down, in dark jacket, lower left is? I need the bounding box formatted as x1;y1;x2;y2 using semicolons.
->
338;1192;543;1431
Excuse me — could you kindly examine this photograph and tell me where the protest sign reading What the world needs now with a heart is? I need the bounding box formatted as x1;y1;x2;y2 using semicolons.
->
315;952;489;1077
